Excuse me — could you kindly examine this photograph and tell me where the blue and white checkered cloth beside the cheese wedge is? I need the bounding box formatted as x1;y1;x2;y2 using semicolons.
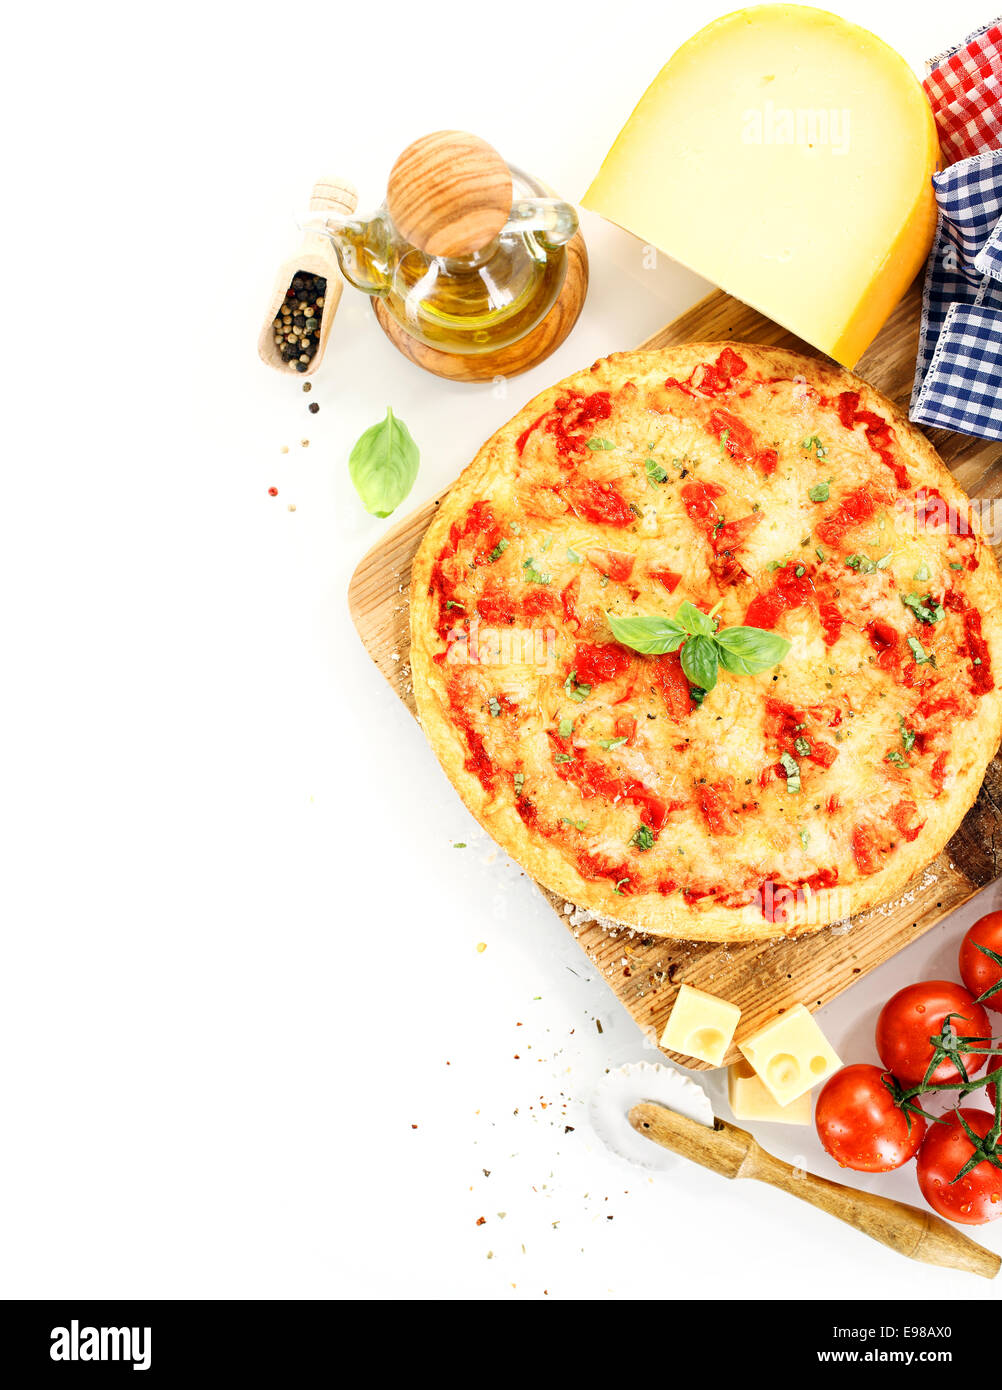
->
909;31;1002;439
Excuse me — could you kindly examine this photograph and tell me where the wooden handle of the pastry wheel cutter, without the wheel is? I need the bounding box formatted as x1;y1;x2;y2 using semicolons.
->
630;1102;1002;1279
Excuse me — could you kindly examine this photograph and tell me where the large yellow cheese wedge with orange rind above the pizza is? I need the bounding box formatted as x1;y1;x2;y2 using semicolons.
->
584;4;939;367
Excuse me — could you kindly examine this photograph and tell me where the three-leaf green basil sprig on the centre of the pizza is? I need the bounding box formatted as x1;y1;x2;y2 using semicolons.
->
606;600;789;691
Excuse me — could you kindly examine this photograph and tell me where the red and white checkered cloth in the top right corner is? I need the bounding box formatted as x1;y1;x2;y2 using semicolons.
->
923;18;1002;164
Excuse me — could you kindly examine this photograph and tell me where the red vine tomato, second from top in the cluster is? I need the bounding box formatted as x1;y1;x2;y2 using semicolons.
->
877;980;991;1086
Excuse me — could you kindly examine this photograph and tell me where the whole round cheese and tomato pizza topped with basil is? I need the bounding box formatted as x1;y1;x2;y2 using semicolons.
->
410;343;1002;941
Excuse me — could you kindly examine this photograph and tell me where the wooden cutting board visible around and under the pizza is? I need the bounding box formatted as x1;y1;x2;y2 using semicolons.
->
349;285;1002;1068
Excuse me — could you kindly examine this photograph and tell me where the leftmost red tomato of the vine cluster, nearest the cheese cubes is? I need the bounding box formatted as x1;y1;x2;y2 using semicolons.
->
814;1062;926;1173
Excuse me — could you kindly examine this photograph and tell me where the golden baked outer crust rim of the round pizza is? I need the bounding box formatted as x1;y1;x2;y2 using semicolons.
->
410;343;1002;941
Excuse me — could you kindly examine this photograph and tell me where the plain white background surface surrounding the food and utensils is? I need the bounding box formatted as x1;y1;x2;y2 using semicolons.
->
0;0;1002;1300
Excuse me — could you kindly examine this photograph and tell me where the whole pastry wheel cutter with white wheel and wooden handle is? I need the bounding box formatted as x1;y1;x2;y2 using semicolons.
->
589;1062;1002;1279
